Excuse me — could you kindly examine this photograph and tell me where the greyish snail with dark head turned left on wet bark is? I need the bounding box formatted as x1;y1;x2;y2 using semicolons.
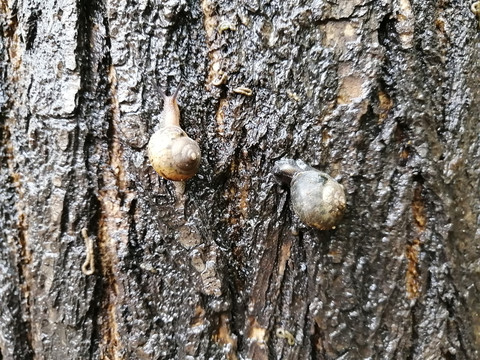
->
272;159;346;230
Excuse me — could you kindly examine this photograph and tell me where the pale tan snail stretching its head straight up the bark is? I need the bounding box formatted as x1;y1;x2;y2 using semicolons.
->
148;86;201;181
